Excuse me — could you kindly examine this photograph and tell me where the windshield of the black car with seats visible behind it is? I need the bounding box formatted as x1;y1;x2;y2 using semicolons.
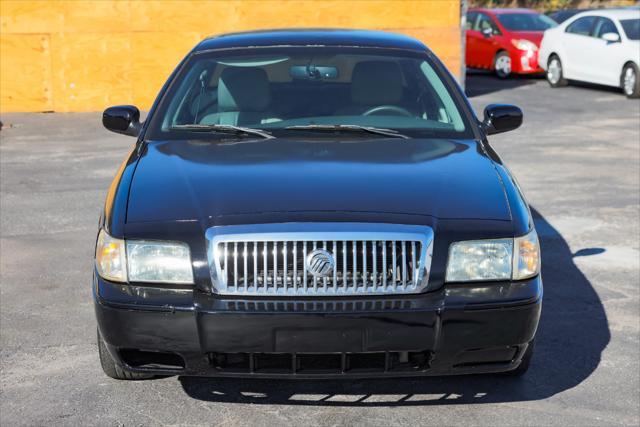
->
148;47;473;139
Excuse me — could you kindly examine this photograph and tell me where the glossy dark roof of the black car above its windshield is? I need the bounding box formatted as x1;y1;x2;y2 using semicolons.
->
194;28;428;51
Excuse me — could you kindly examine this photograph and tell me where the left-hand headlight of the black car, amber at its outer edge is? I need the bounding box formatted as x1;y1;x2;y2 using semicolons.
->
96;230;193;284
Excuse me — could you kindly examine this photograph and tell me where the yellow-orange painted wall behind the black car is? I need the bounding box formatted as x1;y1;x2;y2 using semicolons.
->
0;0;461;112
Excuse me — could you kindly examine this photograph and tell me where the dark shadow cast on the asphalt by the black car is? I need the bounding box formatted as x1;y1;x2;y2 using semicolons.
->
179;210;610;407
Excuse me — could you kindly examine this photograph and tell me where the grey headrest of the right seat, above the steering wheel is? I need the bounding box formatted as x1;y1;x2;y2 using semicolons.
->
351;61;402;105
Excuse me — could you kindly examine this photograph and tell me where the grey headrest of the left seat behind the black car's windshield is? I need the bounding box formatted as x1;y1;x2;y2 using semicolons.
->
218;67;271;112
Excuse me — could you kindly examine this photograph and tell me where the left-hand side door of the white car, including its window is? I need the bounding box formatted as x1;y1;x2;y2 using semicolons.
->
560;16;598;81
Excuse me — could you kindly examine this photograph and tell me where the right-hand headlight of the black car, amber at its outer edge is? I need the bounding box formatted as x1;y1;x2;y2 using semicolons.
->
446;230;540;282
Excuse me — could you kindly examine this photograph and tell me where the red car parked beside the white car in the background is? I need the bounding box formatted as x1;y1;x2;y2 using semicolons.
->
466;8;558;79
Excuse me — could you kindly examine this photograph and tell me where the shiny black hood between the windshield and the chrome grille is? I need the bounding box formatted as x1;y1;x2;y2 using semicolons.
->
126;136;510;223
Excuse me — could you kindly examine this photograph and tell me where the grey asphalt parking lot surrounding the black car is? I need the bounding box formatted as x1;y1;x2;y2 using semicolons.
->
0;75;640;426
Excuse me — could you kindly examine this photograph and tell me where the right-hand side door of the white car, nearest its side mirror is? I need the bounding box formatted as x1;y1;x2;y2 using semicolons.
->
588;16;624;86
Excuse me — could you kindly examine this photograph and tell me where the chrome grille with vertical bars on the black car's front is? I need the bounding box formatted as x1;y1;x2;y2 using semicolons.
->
207;223;433;296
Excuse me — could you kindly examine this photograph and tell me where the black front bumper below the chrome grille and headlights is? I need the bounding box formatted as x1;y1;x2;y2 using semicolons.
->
93;275;542;378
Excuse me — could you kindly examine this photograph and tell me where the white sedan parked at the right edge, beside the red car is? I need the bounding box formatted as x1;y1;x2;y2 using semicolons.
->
538;8;640;98
